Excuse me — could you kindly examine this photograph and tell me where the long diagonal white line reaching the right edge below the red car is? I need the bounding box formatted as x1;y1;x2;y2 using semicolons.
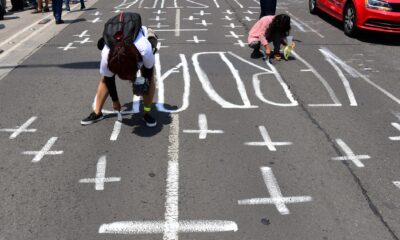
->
320;47;400;104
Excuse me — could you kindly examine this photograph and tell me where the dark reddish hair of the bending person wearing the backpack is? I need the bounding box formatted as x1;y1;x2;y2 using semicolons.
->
108;41;141;81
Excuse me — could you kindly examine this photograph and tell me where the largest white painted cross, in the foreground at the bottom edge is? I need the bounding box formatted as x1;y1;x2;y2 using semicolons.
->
99;114;238;240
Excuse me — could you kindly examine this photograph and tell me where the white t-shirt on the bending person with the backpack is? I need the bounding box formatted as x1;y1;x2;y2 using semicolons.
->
100;26;155;77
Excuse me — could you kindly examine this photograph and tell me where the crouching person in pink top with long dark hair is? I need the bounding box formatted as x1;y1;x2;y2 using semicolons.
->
248;14;290;61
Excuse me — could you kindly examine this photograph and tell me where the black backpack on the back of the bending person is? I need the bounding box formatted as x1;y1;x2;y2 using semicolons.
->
103;12;142;48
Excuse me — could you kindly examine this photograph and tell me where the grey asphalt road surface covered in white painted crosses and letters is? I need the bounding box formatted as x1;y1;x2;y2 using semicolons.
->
0;0;400;240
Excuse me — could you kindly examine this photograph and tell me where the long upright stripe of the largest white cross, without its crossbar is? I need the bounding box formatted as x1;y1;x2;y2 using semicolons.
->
163;114;179;240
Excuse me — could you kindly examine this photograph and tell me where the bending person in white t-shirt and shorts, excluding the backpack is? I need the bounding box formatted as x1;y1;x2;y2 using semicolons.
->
81;14;157;127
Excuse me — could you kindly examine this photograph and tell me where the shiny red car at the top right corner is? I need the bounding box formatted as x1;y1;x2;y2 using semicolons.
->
309;0;400;36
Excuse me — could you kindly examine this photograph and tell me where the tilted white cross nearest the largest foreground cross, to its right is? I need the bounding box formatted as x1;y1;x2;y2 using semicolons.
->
238;167;312;215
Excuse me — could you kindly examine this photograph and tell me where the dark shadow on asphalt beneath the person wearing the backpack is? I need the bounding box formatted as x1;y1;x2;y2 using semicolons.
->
117;102;178;137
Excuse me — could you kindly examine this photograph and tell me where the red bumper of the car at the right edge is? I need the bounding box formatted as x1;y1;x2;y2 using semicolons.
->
357;7;400;33
